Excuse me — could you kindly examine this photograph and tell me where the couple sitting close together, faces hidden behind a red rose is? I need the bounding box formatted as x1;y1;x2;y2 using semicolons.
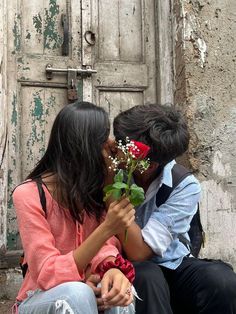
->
13;102;236;314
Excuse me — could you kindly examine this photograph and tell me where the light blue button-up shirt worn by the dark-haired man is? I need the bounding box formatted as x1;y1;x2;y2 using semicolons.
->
136;160;201;269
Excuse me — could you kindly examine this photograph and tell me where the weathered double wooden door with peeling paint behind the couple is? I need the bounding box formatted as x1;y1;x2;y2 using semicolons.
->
3;0;156;258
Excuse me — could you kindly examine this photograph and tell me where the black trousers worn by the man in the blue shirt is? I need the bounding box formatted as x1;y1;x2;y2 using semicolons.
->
134;257;236;314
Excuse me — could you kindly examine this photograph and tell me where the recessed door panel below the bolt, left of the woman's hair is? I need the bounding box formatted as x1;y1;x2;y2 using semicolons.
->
20;87;67;178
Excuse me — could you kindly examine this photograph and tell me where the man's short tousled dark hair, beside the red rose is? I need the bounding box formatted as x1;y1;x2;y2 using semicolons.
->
113;104;189;166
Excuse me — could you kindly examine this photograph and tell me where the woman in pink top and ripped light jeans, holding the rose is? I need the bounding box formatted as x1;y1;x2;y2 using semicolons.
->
13;102;135;314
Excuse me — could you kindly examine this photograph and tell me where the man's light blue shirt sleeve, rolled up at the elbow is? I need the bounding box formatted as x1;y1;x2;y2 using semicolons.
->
142;175;201;257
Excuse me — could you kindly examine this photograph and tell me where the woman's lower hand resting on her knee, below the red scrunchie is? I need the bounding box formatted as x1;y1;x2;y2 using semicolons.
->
101;268;133;309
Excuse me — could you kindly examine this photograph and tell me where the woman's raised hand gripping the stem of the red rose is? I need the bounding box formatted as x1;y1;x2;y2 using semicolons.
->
103;198;135;235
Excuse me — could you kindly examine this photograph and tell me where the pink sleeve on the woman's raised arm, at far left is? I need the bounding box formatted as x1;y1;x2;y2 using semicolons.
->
13;182;84;290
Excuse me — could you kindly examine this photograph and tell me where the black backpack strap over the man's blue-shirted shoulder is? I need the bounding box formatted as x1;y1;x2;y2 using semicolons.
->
156;164;192;207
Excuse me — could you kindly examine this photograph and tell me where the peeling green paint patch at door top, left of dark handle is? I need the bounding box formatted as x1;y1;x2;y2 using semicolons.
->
43;0;63;50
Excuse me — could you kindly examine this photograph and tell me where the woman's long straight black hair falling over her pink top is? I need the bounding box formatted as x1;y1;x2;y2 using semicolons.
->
27;102;110;223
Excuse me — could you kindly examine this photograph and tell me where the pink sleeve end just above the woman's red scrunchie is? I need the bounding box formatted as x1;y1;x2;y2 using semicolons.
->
91;236;121;273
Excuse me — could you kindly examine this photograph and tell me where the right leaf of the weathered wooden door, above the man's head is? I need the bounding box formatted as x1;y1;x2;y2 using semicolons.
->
82;0;157;109
